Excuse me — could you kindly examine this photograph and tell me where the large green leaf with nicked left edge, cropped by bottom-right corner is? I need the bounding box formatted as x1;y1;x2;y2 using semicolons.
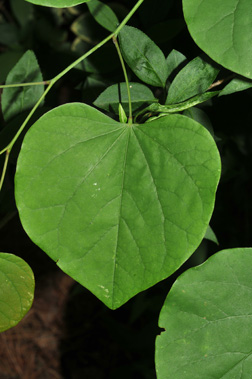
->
156;249;252;379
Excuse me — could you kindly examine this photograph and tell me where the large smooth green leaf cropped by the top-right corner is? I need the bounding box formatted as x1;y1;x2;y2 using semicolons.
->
183;0;252;79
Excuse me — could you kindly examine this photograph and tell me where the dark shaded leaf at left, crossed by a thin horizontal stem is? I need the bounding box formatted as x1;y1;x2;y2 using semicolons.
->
2;50;44;120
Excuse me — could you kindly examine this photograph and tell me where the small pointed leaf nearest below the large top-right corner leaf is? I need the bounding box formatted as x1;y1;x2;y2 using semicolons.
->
166;57;219;104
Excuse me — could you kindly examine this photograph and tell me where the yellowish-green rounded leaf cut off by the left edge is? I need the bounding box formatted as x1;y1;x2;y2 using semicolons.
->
0;253;34;332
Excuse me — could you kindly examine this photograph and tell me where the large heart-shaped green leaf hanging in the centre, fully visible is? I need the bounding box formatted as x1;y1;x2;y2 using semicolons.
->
15;103;220;308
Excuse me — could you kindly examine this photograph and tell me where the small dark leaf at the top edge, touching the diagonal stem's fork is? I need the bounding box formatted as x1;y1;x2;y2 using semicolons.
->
87;0;119;32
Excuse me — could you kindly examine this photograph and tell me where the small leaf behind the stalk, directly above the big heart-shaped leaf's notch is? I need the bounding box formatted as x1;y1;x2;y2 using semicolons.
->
94;83;157;114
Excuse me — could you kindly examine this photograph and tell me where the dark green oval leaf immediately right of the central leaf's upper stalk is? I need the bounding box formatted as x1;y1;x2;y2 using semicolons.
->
119;25;167;87
